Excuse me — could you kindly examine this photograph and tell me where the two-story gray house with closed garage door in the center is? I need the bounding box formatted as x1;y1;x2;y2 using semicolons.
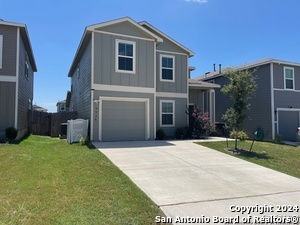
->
67;17;218;141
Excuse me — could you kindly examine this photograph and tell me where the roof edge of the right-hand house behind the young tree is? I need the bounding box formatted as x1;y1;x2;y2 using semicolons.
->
194;58;300;80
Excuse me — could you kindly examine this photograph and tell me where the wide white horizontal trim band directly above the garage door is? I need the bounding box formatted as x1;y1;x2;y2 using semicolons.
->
92;84;155;94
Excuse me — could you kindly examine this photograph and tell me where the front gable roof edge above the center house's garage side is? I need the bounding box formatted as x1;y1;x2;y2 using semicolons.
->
68;17;163;77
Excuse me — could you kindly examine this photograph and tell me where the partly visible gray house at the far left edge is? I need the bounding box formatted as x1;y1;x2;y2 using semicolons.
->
0;20;37;138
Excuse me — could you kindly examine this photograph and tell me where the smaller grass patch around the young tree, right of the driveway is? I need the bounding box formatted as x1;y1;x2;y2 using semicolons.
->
198;141;300;178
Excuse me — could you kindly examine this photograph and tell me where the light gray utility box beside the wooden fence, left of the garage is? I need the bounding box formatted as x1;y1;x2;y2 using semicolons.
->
67;119;89;144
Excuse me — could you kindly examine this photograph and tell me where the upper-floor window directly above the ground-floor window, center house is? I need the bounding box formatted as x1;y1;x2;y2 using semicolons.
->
160;55;175;81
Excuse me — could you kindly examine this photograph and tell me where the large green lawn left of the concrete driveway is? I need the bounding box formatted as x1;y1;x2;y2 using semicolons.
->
0;136;163;225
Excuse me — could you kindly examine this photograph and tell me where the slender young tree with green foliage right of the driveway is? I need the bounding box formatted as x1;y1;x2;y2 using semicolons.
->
221;69;257;149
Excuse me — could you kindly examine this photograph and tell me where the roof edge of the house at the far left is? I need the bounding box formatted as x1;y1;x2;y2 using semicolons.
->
0;20;37;72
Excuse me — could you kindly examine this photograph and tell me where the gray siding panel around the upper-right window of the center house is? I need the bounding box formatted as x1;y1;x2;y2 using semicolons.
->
156;52;188;93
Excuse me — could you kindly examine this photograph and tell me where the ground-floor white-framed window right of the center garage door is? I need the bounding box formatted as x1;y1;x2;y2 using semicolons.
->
160;100;175;127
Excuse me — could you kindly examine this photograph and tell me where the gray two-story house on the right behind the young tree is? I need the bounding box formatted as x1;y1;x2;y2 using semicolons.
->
197;59;300;140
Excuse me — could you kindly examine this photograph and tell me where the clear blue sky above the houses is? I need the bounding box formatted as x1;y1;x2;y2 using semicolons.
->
0;0;300;111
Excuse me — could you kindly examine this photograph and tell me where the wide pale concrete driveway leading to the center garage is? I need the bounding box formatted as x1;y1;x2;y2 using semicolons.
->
93;141;300;224
